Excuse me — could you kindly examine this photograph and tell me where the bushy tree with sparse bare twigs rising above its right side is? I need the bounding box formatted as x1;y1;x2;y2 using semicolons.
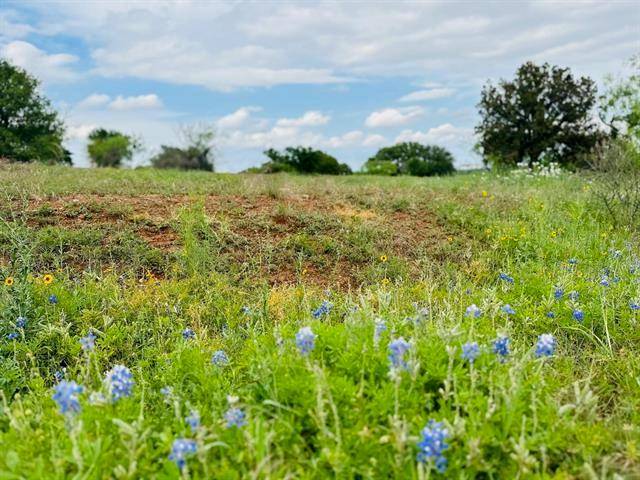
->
151;124;215;172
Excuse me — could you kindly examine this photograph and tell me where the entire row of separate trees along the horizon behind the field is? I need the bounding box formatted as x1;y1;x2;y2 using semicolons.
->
0;58;640;176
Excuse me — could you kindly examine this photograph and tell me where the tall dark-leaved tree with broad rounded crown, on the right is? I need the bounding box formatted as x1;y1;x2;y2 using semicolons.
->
476;62;599;166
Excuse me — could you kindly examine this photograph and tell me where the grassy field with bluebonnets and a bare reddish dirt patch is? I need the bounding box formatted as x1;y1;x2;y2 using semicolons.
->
0;166;640;479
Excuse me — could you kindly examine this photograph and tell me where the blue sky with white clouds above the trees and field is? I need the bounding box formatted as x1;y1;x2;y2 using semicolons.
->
0;0;640;172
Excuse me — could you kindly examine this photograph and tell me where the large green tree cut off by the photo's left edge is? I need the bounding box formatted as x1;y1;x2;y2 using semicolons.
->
0;59;71;164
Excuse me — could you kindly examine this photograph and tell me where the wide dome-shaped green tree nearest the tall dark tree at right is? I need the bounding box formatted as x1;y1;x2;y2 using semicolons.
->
367;142;455;177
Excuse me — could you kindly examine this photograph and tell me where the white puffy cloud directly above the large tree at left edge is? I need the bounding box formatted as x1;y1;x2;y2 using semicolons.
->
0;40;78;83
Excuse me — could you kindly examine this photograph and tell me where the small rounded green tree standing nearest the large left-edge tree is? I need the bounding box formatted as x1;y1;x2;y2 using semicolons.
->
87;128;140;168
